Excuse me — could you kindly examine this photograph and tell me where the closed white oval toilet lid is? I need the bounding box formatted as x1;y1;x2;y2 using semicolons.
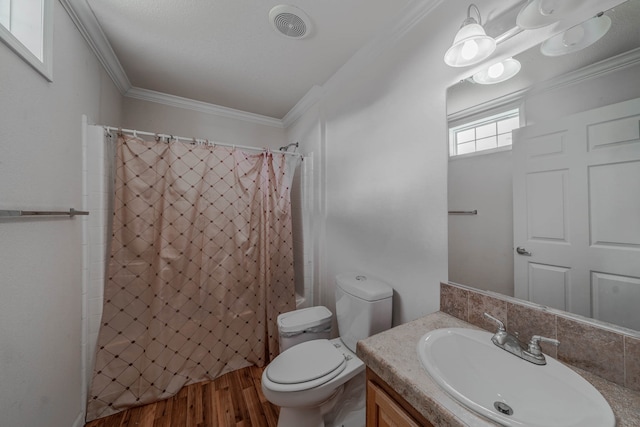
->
267;340;346;384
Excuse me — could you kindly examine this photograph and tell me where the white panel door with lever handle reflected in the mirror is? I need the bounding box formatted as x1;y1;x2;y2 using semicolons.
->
513;99;640;329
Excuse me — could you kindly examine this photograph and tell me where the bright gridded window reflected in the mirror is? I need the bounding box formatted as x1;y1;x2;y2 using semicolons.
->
449;108;520;157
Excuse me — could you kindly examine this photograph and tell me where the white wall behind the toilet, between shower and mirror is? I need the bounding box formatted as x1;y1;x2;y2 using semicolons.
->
293;1;468;324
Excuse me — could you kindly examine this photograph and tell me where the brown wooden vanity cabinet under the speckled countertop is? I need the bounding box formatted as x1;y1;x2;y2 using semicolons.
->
367;368;434;427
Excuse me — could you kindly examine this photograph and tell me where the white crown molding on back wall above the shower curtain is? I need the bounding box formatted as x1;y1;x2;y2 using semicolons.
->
124;87;284;128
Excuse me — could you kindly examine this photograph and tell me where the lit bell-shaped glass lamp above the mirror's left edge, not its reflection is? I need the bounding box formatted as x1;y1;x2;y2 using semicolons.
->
444;4;496;67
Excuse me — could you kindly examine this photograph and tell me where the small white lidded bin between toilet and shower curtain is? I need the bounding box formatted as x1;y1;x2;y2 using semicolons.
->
278;306;332;352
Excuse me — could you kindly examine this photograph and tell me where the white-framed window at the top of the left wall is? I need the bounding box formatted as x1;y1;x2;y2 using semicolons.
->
0;0;53;81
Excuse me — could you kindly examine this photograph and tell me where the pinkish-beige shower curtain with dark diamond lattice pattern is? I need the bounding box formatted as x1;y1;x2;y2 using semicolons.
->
87;136;298;421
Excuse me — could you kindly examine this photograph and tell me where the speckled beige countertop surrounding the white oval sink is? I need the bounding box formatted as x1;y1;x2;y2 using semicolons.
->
357;312;640;427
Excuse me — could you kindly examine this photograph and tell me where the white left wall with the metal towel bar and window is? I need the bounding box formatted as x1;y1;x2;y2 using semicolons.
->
0;2;121;427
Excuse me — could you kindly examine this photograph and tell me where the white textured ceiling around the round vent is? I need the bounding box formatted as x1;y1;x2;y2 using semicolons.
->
88;0;409;119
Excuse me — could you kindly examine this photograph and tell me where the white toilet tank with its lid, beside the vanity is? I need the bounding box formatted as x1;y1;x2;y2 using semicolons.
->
336;273;393;352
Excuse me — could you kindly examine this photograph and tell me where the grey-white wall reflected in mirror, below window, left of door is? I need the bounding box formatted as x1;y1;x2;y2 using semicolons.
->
449;150;513;296
